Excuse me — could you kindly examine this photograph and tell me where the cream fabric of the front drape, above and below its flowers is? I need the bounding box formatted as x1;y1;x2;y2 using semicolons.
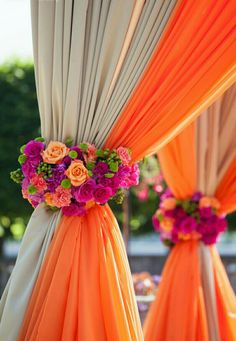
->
0;0;176;341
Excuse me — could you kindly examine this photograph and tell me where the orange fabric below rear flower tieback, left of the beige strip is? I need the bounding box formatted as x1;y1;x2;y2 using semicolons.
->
144;241;208;341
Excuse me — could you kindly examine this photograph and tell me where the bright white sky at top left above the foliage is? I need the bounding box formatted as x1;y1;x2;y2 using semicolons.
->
0;0;33;63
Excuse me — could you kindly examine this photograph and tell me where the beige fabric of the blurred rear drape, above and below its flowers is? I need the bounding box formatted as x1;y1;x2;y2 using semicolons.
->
196;85;236;341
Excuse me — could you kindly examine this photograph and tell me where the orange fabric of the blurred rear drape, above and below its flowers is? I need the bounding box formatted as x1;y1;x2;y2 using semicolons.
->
144;102;236;341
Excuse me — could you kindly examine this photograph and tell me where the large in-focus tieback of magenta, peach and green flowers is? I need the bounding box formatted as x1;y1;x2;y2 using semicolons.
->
11;138;139;216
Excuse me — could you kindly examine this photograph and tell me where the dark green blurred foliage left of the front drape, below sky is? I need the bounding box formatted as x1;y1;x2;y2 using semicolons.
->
0;60;40;237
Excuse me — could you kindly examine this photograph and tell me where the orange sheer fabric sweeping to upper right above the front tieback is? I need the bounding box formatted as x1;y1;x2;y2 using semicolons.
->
106;0;236;160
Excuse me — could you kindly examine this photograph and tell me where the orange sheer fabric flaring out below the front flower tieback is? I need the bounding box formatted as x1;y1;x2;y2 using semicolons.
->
19;205;142;341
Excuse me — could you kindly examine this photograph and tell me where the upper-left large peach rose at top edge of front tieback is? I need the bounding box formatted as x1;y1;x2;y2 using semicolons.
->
42;141;69;164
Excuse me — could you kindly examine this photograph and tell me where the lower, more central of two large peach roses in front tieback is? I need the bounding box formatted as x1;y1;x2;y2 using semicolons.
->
65;160;89;186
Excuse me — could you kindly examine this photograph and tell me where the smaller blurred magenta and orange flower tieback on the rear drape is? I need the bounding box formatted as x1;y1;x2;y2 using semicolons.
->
152;189;227;246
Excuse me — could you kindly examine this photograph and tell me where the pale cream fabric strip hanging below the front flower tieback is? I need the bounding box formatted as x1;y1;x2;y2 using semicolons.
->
0;205;61;341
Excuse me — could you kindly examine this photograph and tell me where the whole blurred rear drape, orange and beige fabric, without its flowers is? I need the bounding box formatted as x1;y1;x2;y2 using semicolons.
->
144;86;236;341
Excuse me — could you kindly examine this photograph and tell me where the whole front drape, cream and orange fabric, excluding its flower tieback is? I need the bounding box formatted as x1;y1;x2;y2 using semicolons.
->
0;0;236;340
